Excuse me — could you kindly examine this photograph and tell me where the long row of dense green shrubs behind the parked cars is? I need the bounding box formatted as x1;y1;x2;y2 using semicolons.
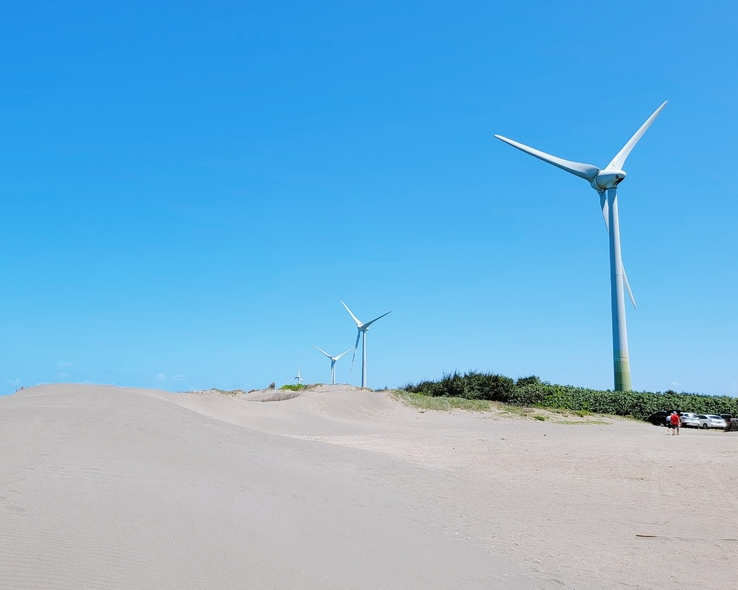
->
403;371;738;420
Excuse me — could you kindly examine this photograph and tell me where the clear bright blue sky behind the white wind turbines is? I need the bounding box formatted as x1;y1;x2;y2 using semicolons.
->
0;0;738;395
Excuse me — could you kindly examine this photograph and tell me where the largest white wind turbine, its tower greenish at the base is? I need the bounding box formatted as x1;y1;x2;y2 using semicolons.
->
495;101;666;391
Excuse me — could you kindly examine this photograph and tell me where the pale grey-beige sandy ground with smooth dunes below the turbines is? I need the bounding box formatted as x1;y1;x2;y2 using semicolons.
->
0;385;738;590
